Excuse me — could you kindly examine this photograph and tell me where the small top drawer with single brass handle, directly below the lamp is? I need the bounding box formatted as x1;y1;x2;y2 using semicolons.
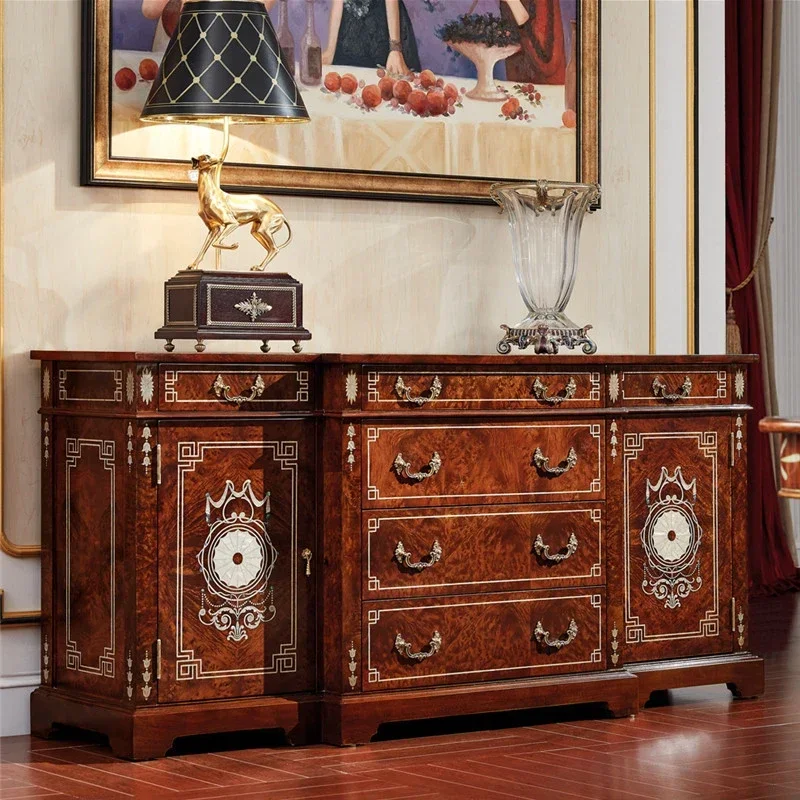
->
159;364;313;414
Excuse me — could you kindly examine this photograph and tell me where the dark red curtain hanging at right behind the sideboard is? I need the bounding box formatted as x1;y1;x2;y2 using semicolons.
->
725;0;796;592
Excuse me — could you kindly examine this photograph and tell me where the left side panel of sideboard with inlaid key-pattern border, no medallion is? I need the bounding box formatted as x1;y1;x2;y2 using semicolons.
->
54;417;128;702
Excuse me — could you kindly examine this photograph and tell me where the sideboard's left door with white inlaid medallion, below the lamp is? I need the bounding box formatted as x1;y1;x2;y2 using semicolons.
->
158;420;318;702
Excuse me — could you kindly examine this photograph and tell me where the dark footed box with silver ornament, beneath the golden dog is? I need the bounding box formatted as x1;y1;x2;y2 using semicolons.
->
155;270;311;353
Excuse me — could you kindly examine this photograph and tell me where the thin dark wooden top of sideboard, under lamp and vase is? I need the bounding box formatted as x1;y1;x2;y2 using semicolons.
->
31;350;758;368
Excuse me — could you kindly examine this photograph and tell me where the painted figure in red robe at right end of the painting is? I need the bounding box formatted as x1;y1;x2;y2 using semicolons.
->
500;0;567;84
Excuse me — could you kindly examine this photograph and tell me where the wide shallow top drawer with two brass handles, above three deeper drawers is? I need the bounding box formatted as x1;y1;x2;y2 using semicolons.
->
363;368;602;411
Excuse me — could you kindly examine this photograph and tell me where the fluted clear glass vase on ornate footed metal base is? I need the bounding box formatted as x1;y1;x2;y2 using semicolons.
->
491;181;600;354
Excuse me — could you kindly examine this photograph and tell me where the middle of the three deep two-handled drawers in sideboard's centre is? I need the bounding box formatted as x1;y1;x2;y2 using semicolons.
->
363;503;605;599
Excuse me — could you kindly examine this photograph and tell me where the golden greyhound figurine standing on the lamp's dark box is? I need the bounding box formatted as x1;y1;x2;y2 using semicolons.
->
188;131;292;270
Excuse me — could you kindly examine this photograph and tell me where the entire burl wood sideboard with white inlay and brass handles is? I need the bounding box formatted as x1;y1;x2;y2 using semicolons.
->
31;352;764;758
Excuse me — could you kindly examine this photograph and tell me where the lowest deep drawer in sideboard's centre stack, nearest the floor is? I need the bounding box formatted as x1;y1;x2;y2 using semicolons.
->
363;590;605;691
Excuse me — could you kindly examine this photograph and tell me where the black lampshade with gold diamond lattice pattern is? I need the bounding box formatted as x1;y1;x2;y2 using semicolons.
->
141;0;308;122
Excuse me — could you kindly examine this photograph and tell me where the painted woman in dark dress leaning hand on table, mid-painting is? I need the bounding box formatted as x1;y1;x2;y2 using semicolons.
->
322;0;421;75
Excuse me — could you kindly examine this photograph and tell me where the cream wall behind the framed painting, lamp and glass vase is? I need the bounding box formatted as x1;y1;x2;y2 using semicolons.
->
0;0;649;736
